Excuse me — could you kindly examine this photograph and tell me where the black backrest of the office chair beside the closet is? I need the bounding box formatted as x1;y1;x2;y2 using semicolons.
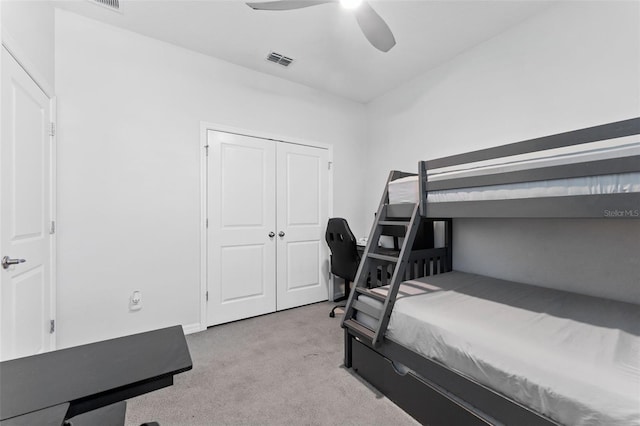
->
324;217;360;282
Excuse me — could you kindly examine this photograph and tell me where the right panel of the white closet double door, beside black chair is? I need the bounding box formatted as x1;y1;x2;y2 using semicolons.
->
277;143;329;310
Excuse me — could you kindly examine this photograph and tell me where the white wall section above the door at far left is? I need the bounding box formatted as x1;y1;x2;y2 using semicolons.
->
0;0;55;96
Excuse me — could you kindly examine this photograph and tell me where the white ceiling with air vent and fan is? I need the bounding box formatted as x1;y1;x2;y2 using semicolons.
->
55;0;551;102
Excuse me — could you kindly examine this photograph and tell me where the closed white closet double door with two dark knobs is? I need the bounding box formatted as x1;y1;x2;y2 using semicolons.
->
207;131;329;326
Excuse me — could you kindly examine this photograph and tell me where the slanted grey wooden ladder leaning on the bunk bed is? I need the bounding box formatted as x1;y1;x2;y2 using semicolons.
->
342;171;421;347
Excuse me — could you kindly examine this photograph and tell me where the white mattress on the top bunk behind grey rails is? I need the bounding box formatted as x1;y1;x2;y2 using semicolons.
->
389;136;640;204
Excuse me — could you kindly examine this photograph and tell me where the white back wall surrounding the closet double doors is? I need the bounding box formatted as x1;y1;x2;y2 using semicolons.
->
55;10;365;347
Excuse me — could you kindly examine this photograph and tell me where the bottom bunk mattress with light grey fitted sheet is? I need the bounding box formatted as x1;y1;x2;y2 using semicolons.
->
358;271;640;425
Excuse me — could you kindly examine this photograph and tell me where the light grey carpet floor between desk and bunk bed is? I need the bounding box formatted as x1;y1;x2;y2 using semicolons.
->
126;302;418;426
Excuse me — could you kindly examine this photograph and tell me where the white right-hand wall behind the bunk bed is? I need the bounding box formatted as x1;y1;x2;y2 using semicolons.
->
363;1;640;303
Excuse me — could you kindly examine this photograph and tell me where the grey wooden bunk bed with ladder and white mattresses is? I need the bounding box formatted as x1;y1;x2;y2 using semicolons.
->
342;118;640;425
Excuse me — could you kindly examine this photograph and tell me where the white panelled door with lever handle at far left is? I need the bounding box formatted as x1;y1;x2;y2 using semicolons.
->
0;47;54;360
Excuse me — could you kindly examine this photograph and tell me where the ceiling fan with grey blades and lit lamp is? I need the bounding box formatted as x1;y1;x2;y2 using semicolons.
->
247;0;396;52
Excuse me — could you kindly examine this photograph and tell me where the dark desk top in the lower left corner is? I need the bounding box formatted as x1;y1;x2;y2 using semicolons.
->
0;326;193;426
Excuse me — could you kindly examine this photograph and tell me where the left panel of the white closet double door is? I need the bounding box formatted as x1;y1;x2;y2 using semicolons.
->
207;131;276;325
